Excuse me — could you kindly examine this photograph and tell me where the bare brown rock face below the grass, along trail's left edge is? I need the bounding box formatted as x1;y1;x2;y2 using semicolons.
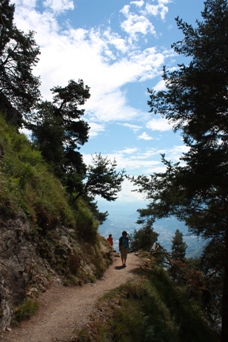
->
0;213;112;330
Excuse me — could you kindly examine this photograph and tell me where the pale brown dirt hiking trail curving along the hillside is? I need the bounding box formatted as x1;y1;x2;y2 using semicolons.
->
0;253;140;342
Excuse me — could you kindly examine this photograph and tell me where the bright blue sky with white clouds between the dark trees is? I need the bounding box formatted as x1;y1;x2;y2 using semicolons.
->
12;0;204;211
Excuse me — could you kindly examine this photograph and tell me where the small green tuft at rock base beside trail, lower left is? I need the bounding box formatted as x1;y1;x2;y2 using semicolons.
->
13;299;39;324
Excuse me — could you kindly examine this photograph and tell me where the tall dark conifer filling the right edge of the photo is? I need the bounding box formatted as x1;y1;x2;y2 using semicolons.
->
133;0;228;342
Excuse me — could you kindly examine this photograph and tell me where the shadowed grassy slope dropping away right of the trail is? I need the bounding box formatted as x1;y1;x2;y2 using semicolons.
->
77;267;218;342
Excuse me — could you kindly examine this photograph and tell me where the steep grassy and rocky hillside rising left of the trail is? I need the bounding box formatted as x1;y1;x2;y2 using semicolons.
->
0;117;112;330
